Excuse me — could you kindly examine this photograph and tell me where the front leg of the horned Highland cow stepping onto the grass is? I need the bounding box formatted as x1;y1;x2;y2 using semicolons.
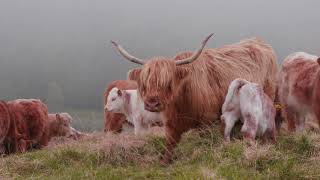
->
160;125;182;165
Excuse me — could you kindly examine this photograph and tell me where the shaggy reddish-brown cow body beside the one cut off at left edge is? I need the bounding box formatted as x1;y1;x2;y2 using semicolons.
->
7;99;48;153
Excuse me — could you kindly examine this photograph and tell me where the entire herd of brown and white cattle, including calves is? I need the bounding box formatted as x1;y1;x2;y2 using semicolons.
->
0;34;320;164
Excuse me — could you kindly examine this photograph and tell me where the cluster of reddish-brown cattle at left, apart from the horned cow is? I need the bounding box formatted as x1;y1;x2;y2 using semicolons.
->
0;99;82;155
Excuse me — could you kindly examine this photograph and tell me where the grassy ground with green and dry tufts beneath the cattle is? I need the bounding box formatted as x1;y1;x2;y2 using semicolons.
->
0;125;320;179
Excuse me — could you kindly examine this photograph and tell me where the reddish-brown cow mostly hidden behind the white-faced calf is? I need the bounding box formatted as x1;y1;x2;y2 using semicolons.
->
103;80;138;132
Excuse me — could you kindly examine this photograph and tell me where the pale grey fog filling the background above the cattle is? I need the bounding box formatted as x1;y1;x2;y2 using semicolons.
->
0;0;320;109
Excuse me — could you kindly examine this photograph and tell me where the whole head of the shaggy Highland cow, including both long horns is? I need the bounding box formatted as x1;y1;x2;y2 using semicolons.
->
112;34;213;112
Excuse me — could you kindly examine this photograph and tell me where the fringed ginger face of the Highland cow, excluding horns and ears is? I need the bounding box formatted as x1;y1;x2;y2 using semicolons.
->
137;58;185;112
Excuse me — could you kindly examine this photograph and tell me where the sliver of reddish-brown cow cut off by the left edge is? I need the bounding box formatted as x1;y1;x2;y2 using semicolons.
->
0;101;11;154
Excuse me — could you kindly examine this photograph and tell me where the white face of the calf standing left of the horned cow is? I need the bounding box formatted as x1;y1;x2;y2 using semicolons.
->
105;87;124;113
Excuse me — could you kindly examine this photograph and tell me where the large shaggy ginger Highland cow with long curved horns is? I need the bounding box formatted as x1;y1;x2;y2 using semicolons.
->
112;35;278;164
